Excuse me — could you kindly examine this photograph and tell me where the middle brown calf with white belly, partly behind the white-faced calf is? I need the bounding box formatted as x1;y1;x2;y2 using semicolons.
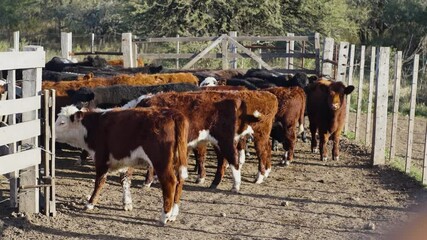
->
137;91;264;192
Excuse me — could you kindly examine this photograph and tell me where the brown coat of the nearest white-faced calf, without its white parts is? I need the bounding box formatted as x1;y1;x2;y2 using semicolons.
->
75;108;188;220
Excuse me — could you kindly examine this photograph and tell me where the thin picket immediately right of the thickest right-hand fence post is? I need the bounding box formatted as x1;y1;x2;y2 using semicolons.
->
389;51;402;160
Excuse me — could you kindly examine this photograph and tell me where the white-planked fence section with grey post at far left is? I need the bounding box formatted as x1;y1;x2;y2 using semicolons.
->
0;41;56;216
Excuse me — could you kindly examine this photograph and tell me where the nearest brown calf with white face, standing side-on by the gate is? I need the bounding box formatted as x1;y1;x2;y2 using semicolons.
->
55;105;189;224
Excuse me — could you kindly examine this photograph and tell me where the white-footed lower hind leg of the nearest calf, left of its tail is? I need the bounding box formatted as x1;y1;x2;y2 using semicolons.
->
157;170;178;224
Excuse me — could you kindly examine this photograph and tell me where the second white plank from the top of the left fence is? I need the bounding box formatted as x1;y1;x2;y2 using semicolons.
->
0;96;40;116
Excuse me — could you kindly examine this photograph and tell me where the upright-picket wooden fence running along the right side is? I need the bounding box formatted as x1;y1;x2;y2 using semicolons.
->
332;43;427;184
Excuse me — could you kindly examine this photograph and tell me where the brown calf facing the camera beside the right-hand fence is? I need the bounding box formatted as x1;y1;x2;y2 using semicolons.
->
307;79;354;161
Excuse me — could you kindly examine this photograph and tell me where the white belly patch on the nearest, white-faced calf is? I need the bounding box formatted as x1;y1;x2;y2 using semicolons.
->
107;146;153;171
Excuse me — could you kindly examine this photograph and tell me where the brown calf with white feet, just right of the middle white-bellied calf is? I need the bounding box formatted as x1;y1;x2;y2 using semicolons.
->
192;90;278;187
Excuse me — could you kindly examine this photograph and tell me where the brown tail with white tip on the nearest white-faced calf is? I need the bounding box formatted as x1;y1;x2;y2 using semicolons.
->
174;114;189;179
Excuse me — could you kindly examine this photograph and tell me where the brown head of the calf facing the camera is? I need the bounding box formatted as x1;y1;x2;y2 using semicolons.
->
320;82;354;111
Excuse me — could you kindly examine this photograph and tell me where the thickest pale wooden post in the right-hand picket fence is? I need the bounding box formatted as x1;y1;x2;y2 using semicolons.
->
372;47;390;165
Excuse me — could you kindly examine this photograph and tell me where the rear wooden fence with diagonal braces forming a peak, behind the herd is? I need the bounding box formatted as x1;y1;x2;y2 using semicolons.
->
135;32;321;75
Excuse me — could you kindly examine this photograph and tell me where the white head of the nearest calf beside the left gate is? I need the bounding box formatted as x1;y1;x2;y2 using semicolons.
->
55;105;87;148
